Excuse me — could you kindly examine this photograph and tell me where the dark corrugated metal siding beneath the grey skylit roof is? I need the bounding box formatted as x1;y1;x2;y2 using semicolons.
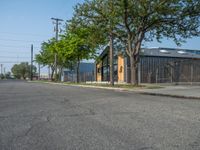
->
140;56;200;83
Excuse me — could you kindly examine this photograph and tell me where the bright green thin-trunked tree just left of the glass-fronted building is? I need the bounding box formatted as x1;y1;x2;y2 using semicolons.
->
62;27;95;82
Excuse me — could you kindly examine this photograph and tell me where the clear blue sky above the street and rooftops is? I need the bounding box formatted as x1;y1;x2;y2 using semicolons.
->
0;0;200;72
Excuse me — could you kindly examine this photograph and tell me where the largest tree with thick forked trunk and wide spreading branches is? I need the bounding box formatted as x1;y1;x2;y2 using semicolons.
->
119;0;200;84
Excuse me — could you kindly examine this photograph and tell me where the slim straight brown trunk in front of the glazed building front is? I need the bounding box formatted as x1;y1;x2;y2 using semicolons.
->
110;33;114;86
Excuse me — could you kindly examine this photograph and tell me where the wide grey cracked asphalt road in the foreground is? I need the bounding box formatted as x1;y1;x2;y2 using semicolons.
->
0;81;200;150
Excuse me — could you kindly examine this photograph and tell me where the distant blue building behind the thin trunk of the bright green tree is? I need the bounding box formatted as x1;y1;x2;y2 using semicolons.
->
62;62;95;82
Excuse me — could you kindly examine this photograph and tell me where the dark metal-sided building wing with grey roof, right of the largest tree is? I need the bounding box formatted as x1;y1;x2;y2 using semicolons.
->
138;48;200;83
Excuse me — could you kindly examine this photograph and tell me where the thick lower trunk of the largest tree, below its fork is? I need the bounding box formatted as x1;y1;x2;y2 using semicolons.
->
130;56;138;85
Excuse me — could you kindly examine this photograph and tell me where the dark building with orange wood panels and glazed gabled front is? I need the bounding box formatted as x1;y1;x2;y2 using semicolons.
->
96;48;200;83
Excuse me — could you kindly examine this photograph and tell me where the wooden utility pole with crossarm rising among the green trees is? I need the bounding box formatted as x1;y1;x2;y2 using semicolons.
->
51;18;63;80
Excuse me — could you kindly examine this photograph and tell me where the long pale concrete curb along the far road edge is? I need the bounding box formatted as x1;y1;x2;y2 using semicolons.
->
28;81;200;100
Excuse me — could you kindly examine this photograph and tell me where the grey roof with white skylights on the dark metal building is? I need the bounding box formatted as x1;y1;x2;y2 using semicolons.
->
141;47;200;59
